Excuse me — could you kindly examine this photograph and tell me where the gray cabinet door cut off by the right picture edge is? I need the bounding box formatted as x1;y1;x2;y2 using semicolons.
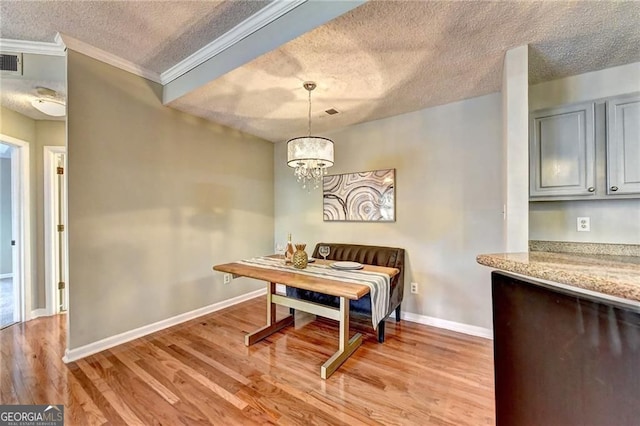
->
607;95;640;195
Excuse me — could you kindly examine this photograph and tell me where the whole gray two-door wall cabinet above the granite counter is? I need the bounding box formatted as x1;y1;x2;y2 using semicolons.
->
529;93;640;201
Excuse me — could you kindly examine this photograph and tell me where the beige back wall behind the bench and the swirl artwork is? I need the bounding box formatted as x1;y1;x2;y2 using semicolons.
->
274;93;504;329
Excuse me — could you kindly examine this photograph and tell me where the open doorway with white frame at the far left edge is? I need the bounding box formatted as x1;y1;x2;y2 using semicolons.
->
0;134;31;328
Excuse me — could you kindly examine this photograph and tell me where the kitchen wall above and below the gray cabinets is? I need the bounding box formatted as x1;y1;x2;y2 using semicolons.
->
529;62;640;244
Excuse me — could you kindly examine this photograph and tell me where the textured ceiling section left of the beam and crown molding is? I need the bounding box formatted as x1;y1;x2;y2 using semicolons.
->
0;0;269;73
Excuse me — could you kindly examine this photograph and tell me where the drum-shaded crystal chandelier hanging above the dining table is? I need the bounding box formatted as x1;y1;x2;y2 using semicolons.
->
287;81;333;189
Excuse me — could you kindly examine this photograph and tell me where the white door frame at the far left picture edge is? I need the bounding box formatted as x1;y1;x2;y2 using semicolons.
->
0;133;33;322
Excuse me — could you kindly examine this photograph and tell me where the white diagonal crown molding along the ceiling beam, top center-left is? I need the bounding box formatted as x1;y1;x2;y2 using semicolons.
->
160;0;307;85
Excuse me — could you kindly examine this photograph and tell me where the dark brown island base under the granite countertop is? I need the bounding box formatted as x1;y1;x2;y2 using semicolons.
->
492;272;640;426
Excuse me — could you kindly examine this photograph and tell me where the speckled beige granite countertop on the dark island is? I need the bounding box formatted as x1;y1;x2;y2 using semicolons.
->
476;243;640;302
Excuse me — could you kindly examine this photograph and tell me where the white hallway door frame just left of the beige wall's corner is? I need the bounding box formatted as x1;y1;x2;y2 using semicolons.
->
43;145;69;315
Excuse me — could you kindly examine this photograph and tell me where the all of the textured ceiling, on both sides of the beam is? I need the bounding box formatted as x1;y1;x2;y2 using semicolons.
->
0;1;640;141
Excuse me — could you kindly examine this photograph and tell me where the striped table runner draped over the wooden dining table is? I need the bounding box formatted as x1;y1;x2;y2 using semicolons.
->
237;257;391;330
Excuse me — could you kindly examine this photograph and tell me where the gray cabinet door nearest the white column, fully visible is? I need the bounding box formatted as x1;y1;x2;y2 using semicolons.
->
529;103;595;198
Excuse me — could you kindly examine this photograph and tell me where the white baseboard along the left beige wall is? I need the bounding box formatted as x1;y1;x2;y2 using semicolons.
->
62;288;267;363
